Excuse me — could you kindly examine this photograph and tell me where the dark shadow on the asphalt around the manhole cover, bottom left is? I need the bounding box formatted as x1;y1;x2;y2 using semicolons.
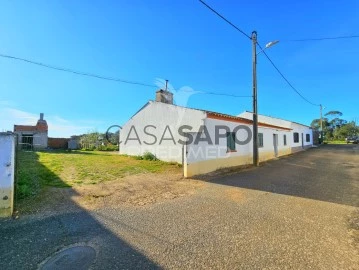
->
0;151;159;269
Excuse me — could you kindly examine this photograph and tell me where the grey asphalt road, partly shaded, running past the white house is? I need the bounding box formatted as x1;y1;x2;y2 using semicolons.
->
0;145;359;269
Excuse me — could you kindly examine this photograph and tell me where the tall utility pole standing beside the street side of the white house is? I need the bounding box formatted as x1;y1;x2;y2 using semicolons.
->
251;31;259;166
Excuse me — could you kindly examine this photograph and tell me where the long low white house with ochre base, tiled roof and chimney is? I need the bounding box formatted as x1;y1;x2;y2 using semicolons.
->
120;90;313;177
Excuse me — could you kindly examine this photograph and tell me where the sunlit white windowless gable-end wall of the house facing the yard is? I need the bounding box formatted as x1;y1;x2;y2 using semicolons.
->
119;101;206;163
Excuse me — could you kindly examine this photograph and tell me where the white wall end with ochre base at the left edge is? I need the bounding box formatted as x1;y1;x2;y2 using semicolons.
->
0;132;16;217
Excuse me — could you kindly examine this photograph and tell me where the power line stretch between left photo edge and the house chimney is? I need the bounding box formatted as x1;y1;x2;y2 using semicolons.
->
0;54;155;88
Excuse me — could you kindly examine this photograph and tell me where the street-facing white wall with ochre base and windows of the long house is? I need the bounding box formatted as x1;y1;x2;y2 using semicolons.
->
184;118;291;177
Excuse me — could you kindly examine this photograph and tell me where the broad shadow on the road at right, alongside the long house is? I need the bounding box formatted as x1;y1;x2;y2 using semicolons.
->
200;145;359;206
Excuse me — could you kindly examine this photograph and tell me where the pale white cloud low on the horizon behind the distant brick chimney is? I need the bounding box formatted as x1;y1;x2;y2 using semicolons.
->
0;108;98;137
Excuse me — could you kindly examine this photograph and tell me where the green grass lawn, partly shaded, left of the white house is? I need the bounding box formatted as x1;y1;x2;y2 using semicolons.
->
16;151;179;199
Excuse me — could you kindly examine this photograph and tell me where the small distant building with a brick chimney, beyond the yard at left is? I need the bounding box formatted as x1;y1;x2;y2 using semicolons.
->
14;113;48;150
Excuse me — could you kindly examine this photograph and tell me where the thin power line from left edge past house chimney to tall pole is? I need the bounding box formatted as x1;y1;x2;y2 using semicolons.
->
0;51;251;98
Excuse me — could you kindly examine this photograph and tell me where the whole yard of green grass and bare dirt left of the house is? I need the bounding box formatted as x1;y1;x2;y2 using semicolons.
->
16;151;202;214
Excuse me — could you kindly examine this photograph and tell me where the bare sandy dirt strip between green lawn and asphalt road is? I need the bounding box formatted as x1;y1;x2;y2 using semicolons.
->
17;168;204;215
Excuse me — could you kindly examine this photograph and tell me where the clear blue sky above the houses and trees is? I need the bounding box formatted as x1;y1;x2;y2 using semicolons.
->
0;0;359;136
